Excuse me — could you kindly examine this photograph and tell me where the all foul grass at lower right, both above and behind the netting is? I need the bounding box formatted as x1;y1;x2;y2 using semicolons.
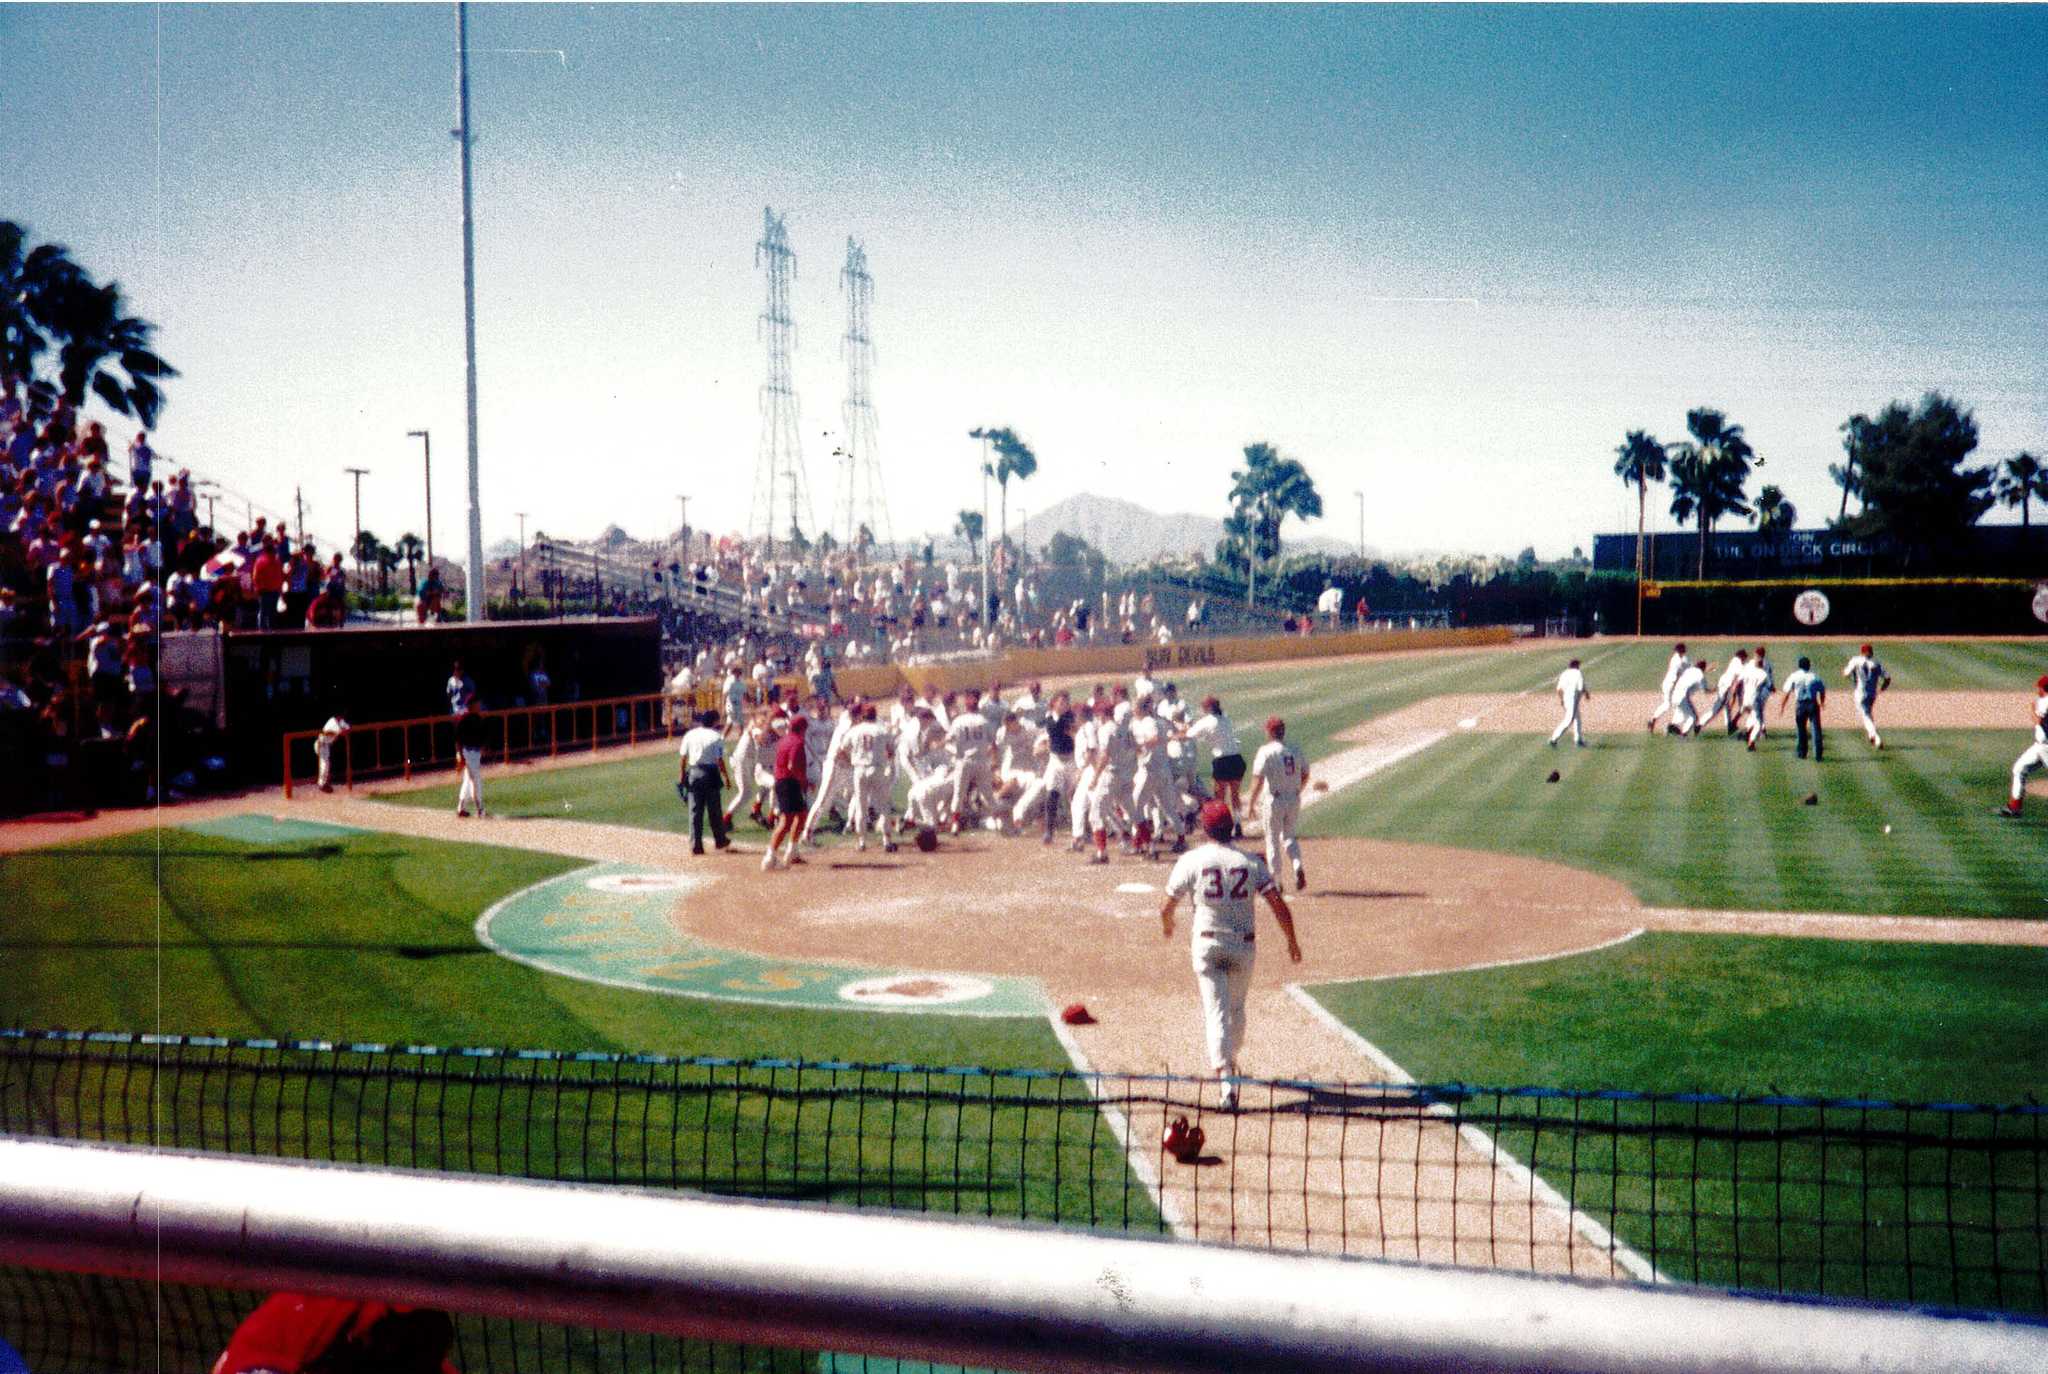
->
1315;934;2048;1311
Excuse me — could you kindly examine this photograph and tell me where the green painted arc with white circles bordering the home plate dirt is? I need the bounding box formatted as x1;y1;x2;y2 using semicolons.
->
477;864;1044;1016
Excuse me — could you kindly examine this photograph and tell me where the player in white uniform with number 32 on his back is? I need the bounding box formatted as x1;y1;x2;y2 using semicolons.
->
1159;801;1300;1112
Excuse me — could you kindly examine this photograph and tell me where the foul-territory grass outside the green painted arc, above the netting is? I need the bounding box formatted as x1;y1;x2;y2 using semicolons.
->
0;829;1067;1069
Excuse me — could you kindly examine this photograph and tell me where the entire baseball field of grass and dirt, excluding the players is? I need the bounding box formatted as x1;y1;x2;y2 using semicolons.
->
0;641;2048;1343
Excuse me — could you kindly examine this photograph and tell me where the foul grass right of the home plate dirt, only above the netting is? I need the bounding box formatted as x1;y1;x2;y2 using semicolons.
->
1313;932;2048;1102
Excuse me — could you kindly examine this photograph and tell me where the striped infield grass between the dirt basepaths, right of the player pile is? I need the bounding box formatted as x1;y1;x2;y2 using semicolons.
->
1303;731;2048;919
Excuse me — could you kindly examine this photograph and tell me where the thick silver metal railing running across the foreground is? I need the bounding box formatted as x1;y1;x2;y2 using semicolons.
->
0;1139;2048;1374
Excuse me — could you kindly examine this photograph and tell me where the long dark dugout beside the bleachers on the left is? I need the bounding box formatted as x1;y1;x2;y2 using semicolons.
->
203;616;662;780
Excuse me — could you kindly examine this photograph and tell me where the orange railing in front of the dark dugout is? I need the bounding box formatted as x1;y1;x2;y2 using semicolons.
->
281;688;717;801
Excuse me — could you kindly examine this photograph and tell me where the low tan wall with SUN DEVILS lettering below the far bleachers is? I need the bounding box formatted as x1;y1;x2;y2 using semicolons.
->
823;627;1516;696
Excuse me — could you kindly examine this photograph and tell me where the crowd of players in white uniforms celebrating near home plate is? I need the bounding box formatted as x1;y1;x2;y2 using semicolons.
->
678;672;1309;891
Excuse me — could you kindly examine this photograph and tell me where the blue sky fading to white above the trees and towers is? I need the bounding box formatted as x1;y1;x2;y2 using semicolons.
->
0;4;2048;555
